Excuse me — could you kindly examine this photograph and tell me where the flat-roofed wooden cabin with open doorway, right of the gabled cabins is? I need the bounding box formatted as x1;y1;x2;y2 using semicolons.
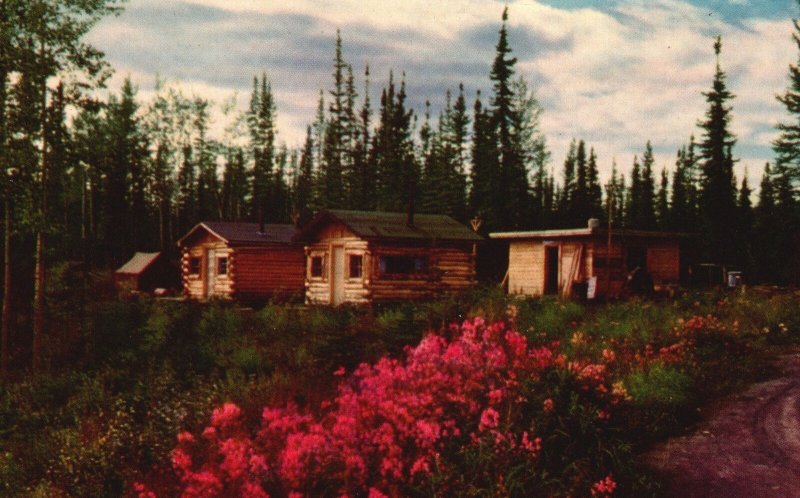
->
489;226;682;299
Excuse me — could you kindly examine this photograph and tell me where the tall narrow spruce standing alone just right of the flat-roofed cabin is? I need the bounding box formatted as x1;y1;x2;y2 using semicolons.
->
698;37;737;264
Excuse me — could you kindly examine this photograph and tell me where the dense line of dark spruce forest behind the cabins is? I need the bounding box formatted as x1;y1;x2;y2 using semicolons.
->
0;0;800;366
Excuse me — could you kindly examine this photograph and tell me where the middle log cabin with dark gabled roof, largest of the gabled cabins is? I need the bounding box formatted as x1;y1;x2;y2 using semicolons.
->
295;210;482;305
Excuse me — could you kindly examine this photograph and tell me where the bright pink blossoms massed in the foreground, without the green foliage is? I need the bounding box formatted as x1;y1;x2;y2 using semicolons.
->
161;318;621;498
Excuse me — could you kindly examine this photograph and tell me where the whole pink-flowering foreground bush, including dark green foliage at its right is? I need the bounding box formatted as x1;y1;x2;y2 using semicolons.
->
161;319;623;496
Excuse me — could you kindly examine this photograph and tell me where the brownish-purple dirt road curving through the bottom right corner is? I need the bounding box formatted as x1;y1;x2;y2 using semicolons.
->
646;352;800;498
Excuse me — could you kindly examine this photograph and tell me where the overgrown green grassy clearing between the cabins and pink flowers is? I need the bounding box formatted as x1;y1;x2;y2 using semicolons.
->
0;289;800;496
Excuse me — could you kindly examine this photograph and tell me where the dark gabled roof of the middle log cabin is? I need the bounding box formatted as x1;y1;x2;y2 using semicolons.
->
295;209;483;242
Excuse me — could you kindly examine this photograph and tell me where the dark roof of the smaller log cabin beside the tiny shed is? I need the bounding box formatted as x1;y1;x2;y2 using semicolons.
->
178;221;297;246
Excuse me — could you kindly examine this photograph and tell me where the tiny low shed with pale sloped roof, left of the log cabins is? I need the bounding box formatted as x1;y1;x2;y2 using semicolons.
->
114;252;180;292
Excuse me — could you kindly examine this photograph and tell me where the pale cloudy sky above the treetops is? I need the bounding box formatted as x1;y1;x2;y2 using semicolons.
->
90;0;800;185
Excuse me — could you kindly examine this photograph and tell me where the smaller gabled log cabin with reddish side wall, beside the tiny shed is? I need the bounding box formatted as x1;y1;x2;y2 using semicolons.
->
178;221;305;302
